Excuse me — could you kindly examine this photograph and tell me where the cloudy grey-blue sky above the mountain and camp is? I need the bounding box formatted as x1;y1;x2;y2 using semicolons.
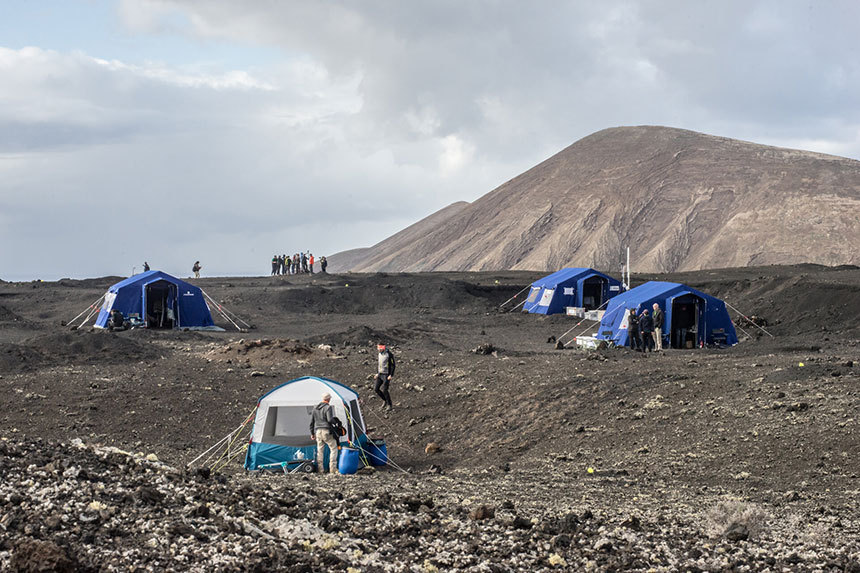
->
0;0;860;281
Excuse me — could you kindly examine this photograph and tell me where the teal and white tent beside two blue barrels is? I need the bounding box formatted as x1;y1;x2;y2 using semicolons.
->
245;376;368;470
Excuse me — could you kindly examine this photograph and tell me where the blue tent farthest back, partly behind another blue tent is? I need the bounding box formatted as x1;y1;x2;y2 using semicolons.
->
523;268;621;314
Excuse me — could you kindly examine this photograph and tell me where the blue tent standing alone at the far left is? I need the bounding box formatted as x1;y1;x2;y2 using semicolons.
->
95;271;223;330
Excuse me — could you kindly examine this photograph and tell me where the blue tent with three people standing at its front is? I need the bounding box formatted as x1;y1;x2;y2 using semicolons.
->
597;281;738;348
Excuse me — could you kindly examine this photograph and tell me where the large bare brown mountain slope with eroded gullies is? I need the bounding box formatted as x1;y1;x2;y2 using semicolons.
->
342;126;860;272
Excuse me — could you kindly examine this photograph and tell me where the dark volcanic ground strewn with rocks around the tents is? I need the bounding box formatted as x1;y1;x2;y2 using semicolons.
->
0;265;860;571
